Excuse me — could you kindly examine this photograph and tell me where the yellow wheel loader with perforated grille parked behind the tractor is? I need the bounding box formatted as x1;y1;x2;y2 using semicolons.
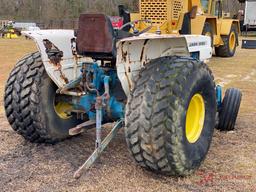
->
130;0;240;57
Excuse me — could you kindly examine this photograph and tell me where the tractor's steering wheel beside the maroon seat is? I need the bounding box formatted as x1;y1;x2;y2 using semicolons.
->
120;19;153;36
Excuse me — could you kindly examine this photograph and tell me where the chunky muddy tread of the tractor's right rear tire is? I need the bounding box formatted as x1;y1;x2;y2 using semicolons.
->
125;56;215;176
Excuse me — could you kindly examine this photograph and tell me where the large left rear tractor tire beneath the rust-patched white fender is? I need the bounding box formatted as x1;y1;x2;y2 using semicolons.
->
4;52;77;143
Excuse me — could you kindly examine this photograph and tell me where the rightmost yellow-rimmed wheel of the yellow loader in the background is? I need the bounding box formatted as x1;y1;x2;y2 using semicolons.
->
215;25;238;57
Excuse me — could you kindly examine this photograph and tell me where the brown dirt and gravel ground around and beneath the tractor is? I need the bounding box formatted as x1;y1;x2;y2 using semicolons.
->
0;39;256;192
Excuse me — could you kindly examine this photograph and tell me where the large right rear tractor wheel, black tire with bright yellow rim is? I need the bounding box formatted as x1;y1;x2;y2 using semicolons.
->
125;57;217;176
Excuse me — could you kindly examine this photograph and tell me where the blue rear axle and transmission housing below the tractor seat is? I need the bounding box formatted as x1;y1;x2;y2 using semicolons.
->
73;63;125;121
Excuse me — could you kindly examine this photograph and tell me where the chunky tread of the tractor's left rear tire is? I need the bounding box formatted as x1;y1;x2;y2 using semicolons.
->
4;52;58;143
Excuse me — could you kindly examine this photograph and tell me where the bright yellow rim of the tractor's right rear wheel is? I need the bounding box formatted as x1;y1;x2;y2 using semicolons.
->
186;94;205;143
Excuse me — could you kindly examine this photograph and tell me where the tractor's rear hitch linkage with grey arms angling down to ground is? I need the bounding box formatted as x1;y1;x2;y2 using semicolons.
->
65;64;124;179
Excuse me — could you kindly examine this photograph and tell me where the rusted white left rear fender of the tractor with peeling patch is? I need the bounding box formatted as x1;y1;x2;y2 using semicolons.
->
22;30;84;88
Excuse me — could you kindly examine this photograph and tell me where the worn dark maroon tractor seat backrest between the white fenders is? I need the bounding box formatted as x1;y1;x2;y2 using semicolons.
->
77;14;116;60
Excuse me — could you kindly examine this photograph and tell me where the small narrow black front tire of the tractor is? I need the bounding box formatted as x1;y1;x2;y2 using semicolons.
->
217;88;242;131
